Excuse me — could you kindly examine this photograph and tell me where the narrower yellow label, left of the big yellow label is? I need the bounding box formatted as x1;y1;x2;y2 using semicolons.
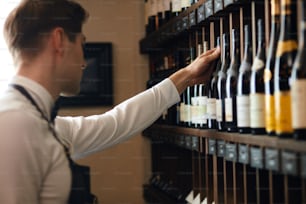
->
265;95;275;132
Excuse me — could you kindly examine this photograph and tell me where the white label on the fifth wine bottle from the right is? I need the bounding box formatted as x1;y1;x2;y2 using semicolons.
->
236;95;250;127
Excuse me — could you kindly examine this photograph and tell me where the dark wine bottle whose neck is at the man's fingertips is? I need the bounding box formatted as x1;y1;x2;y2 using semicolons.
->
207;36;222;129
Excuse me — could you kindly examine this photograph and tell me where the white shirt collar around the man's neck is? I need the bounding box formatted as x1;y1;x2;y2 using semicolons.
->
10;76;54;118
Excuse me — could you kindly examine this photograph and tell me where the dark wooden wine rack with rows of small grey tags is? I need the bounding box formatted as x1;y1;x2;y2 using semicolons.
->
140;0;306;204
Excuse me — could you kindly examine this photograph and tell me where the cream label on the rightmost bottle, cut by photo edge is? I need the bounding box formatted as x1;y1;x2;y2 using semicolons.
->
291;79;306;129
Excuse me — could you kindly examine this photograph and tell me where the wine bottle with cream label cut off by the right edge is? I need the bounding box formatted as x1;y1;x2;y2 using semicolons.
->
291;1;306;140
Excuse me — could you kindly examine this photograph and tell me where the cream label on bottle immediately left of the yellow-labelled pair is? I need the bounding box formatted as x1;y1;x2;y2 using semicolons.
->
250;93;266;128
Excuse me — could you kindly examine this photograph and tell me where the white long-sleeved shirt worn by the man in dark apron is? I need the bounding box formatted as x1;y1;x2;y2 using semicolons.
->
0;76;180;204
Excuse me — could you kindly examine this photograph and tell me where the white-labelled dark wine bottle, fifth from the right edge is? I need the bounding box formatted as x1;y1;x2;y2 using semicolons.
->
237;25;253;133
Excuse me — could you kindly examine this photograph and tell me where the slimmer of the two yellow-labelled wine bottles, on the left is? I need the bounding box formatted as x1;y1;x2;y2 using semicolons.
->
264;0;280;135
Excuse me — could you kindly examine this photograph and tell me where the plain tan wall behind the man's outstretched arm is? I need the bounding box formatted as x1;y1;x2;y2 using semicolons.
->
60;0;150;204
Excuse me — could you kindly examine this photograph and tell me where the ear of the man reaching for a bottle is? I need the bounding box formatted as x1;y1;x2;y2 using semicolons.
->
51;27;66;56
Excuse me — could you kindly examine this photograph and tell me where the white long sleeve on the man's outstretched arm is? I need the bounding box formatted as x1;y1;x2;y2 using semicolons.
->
56;79;180;159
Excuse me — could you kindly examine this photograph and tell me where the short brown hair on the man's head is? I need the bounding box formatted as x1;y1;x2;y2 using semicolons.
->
4;0;88;58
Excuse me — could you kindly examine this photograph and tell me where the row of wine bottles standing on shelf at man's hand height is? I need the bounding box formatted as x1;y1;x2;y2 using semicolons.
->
152;0;306;139
